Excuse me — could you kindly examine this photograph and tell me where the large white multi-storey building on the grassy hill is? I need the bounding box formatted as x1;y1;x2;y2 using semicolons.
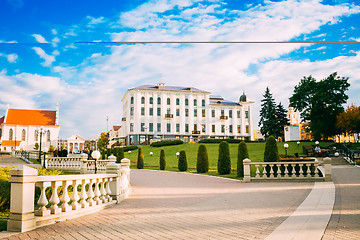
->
121;83;253;145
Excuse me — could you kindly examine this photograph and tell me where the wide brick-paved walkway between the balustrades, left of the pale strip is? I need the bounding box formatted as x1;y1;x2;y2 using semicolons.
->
0;170;313;239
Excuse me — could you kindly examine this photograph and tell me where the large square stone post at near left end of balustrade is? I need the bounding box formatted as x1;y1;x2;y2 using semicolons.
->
7;165;37;232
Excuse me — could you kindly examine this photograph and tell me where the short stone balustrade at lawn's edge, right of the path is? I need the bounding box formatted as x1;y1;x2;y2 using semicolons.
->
243;158;331;182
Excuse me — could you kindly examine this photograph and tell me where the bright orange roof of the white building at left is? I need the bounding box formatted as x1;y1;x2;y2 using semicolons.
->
0;109;56;126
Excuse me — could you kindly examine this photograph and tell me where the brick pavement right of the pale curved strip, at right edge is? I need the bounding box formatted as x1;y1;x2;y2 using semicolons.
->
323;158;360;240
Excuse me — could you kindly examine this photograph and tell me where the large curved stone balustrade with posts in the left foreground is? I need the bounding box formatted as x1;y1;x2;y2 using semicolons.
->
7;159;130;232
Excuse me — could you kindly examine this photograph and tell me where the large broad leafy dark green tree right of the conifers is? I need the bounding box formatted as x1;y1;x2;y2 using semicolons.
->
290;72;350;139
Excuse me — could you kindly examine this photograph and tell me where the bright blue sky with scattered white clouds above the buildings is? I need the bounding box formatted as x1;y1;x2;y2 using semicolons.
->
0;0;360;138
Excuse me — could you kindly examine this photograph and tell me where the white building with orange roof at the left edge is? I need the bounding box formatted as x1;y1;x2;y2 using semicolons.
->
0;108;60;152
